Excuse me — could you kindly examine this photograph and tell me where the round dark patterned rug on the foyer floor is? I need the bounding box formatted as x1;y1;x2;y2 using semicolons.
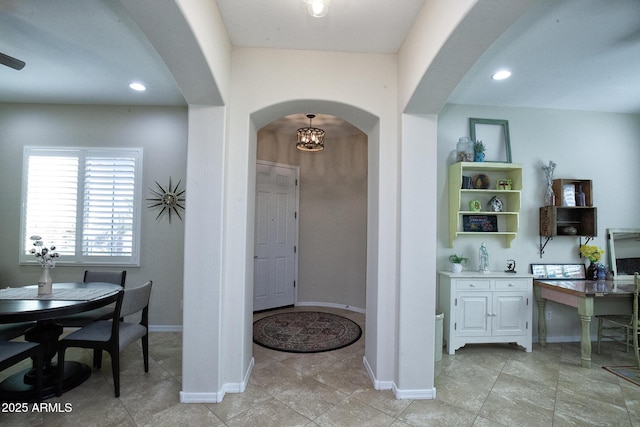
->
253;311;362;353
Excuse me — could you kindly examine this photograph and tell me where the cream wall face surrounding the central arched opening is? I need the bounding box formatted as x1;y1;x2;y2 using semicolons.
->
228;48;398;392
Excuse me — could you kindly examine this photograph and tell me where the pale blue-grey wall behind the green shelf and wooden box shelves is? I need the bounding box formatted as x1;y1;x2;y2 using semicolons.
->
437;104;640;342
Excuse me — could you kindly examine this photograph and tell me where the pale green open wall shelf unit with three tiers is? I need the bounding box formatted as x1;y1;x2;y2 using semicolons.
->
449;162;522;247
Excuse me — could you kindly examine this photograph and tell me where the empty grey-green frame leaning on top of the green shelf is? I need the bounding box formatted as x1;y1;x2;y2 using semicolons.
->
469;118;511;163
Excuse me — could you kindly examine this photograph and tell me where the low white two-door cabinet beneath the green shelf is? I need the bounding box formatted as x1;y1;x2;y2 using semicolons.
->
438;271;533;354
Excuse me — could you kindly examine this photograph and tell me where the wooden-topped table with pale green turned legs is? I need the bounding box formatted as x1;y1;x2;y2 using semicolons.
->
533;279;634;368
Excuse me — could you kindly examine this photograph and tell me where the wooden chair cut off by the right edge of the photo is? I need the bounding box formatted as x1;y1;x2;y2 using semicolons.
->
595;273;640;369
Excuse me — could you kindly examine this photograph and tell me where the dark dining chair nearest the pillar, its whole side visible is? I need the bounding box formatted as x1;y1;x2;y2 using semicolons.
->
57;281;152;397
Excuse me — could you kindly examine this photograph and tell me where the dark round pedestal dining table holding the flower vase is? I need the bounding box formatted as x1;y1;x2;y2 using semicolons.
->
0;282;122;402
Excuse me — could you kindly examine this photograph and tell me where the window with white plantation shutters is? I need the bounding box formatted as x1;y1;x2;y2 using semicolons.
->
20;147;142;265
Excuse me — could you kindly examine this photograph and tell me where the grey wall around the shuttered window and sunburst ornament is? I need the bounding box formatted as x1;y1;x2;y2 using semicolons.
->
0;104;189;329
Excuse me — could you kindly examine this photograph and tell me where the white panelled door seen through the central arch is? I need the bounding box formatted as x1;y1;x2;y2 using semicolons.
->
253;161;298;311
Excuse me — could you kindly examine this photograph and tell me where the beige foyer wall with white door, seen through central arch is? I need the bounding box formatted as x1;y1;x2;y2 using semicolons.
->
253;113;368;313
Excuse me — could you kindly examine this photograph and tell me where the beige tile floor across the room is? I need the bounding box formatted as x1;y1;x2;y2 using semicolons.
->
0;308;640;427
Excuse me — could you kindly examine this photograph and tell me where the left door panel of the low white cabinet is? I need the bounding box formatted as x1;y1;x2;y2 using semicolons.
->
455;292;491;337
